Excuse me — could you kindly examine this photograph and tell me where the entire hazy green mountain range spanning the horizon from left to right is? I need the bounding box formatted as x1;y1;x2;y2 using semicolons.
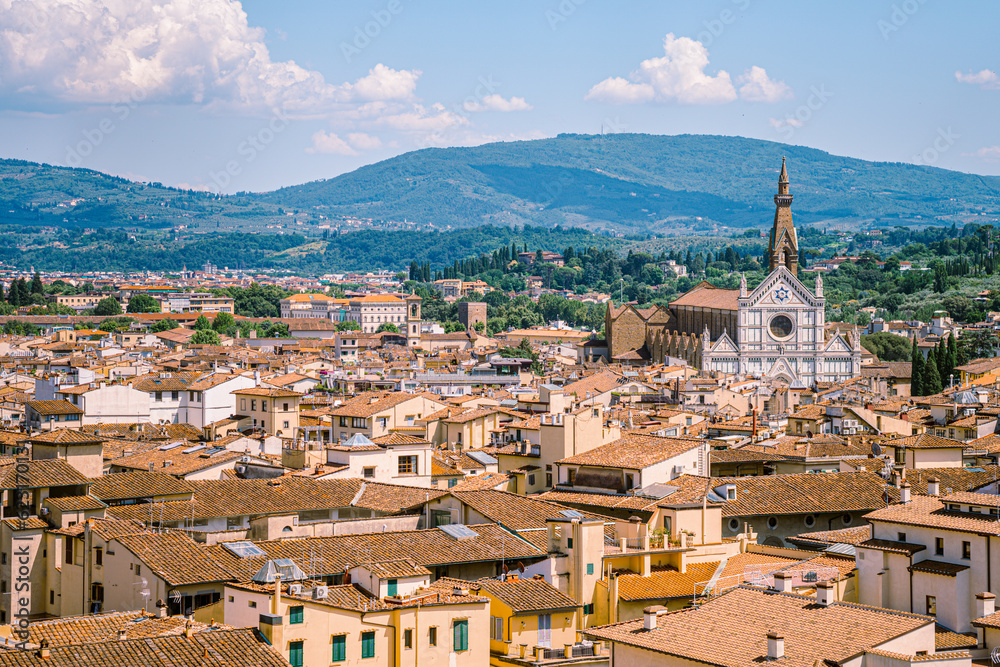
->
0;134;1000;235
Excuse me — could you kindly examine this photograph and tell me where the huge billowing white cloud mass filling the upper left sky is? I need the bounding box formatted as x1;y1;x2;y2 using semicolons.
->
0;0;420;113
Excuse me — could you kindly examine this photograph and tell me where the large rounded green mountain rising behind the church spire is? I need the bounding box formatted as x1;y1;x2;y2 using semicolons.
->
258;134;1000;233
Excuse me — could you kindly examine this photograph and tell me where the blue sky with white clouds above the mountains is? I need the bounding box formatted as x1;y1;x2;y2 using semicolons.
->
0;0;1000;192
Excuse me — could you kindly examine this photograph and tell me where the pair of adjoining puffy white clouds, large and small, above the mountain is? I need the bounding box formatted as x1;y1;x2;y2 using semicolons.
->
584;33;792;104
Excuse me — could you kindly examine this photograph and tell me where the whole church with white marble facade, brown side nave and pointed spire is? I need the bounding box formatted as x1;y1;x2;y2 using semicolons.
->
605;160;861;387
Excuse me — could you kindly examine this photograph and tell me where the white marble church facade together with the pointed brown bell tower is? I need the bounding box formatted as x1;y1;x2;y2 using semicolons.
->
702;159;861;388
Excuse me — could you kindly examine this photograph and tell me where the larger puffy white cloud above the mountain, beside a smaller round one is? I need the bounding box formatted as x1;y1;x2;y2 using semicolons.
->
585;33;736;104
